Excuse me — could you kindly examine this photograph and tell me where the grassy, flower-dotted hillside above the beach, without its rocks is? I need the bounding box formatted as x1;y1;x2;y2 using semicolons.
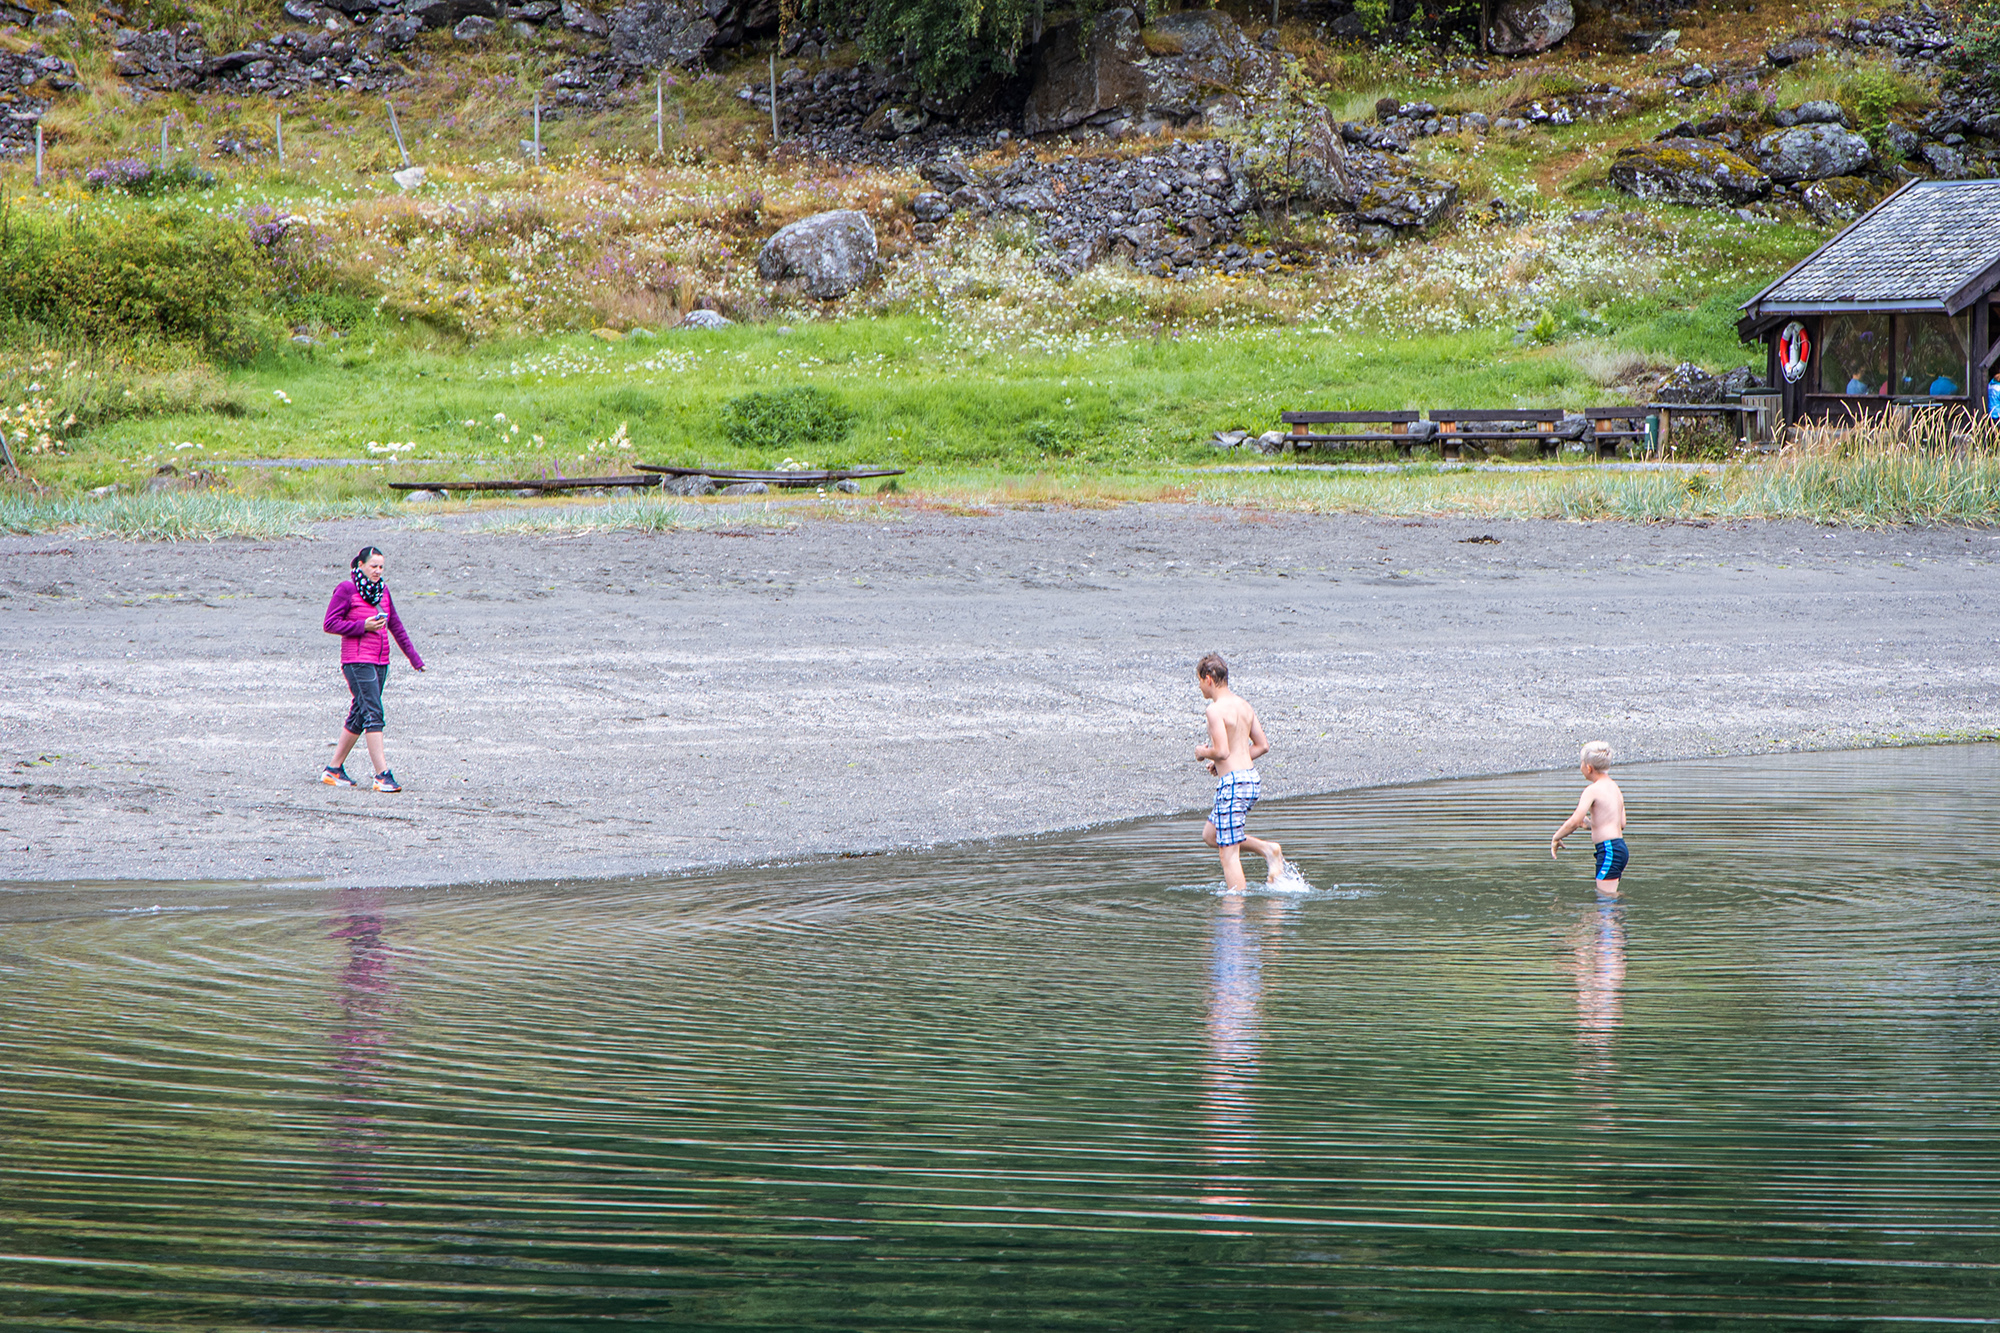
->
0;4;1960;498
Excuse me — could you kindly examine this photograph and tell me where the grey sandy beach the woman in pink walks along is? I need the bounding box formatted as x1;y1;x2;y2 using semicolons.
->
0;506;2000;885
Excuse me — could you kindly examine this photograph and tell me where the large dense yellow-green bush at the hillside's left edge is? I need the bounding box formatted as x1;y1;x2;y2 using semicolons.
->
0;210;268;360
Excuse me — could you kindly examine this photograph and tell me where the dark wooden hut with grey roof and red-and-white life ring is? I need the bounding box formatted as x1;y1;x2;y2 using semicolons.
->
1736;180;2000;422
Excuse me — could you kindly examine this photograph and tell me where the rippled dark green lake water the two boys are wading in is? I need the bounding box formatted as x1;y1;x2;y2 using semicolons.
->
0;747;2000;1333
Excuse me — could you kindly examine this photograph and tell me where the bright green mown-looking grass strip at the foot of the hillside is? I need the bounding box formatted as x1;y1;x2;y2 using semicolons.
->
32;304;1768;500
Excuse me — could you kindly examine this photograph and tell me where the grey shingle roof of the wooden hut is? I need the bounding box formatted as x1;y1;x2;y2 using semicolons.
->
1744;180;2000;314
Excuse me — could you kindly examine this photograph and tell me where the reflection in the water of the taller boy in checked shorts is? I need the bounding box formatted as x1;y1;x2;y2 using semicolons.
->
1202;895;1290;1217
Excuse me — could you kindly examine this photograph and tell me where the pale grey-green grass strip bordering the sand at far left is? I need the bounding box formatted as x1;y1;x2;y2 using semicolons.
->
0;494;396;542
